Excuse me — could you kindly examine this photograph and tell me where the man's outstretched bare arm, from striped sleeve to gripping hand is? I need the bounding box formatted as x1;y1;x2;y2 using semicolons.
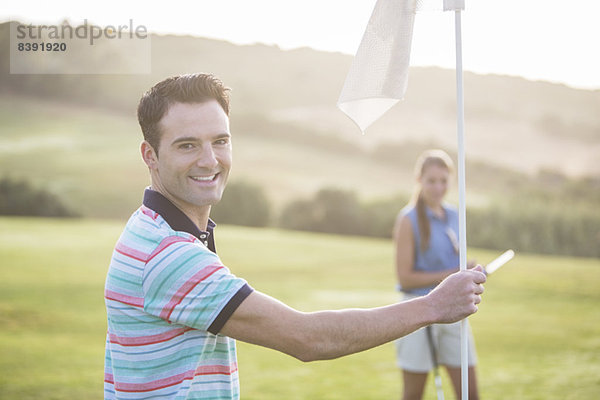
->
220;267;485;361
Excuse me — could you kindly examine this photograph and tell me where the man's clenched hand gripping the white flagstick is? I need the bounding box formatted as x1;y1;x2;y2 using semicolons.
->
426;265;486;323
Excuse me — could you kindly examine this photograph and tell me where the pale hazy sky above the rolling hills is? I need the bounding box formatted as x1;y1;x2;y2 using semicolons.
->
0;0;600;89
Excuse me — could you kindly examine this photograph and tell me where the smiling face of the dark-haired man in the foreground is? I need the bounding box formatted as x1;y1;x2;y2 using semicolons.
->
142;100;231;216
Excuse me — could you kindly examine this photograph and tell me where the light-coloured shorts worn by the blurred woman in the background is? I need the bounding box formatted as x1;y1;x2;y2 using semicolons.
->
396;297;477;373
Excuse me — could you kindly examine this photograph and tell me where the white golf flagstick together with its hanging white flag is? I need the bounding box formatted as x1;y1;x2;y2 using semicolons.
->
338;0;469;394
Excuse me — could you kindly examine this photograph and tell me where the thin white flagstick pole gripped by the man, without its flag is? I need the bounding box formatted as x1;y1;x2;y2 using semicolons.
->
444;0;469;400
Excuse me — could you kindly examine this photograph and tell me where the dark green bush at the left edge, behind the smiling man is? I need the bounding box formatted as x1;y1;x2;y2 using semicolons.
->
0;177;78;217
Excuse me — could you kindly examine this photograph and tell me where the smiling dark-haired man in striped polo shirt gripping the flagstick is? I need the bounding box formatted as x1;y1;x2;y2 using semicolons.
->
104;74;485;399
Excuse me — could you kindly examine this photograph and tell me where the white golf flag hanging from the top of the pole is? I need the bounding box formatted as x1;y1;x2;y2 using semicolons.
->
337;0;464;133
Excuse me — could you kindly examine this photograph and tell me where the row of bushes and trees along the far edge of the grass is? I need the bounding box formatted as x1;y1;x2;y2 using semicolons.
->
0;177;600;257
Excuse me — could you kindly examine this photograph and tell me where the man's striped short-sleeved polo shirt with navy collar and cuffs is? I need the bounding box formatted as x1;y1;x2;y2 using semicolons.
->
104;189;252;400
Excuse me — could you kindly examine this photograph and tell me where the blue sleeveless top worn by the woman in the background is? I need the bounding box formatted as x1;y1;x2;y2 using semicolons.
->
398;204;460;296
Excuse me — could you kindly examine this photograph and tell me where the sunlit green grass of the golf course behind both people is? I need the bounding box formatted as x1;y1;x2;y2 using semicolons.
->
0;218;600;400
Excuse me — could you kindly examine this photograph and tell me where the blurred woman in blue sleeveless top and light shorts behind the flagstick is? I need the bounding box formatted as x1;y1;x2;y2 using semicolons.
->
394;150;479;400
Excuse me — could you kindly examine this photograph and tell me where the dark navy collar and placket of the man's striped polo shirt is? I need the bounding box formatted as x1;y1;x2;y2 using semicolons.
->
143;188;217;253
